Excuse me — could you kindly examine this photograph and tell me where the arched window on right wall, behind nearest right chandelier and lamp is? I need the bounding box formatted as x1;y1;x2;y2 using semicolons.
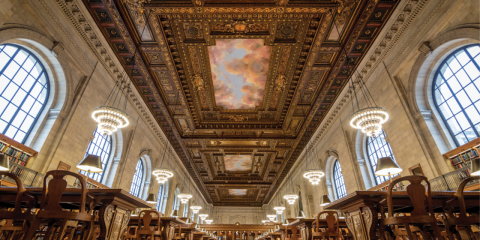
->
367;130;396;185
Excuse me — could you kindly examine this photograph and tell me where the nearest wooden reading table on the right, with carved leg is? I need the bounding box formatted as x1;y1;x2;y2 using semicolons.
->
325;191;480;240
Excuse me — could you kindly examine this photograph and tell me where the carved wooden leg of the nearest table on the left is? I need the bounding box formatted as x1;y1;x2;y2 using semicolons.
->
98;203;131;240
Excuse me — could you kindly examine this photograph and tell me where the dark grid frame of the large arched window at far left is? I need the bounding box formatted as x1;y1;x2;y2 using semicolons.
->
0;43;50;144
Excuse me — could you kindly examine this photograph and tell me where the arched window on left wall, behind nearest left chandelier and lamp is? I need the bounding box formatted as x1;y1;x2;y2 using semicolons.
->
80;129;112;182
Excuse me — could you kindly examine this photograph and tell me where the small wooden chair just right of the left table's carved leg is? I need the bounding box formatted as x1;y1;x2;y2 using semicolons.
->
136;210;162;240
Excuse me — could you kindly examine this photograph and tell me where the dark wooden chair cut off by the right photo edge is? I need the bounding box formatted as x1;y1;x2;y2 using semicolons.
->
443;176;480;240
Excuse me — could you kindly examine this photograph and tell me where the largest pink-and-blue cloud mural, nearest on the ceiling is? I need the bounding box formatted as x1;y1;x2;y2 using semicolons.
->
208;39;270;109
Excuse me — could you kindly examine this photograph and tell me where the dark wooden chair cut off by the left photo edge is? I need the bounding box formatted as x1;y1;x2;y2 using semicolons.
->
0;172;37;239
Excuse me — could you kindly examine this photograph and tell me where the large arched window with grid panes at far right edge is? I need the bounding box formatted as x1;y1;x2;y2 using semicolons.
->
433;44;480;146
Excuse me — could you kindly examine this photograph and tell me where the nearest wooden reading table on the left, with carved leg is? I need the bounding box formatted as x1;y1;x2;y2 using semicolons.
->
0;187;150;240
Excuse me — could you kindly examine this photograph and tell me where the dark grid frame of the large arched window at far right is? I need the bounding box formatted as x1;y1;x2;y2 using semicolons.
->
432;43;480;147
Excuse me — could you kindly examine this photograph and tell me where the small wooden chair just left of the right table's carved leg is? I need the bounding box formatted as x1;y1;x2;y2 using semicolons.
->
312;211;341;240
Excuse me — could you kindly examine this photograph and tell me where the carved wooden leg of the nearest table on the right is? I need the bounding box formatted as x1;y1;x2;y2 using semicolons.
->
345;205;378;240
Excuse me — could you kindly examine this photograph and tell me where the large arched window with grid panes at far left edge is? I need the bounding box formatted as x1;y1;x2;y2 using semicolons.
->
0;44;49;143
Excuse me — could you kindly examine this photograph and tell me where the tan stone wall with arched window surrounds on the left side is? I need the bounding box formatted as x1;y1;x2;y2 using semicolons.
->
0;0;208;214
